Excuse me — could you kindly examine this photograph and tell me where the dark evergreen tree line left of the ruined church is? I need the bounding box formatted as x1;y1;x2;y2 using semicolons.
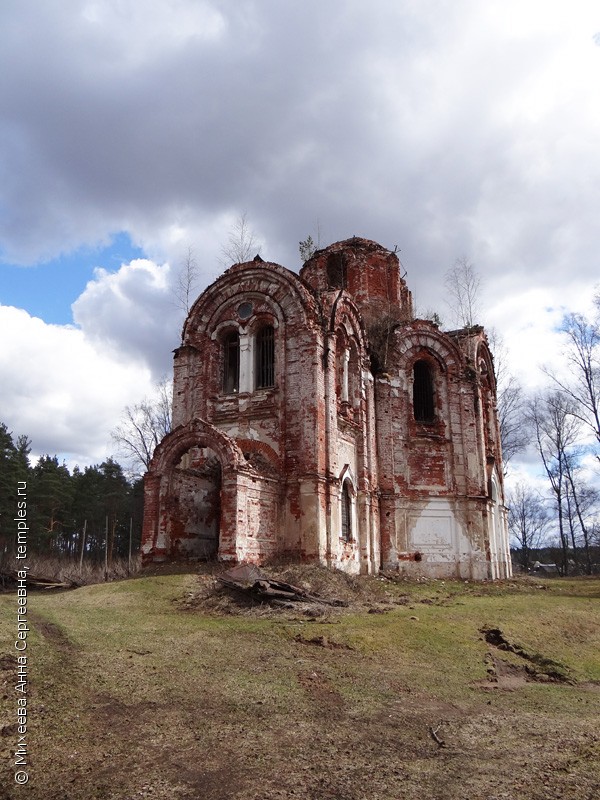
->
0;423;143;564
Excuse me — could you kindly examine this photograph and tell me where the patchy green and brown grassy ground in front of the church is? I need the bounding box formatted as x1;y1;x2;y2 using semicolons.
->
0;569;600;800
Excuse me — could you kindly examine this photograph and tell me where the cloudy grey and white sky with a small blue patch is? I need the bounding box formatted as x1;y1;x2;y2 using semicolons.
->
0;0;600;476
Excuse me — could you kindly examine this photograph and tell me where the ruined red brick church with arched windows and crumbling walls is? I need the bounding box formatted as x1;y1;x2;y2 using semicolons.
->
142;237;511;579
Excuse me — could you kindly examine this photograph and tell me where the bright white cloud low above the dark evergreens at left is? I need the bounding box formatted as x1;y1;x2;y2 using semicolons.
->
0;306;152;465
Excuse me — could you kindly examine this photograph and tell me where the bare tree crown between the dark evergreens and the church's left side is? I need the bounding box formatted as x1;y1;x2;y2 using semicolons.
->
111;378;173;477
